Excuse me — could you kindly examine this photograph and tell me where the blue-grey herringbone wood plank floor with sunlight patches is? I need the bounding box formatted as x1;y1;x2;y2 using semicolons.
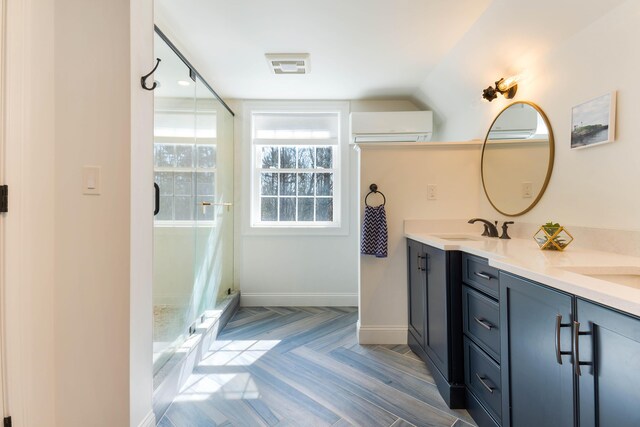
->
158;307;474;427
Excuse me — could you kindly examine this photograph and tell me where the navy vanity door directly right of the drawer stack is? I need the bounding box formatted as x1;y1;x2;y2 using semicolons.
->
500;272;576;427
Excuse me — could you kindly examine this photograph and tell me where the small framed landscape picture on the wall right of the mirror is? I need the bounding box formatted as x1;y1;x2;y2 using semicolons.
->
571;92;616;148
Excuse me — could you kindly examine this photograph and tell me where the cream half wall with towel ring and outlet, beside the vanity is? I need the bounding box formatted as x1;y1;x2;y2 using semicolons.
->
358;144;480;344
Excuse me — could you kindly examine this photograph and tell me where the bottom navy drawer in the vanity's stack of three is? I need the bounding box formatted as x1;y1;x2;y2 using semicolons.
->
464;338;502;421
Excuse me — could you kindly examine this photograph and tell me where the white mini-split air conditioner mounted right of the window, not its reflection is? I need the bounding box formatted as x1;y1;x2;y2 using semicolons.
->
349;111;433;144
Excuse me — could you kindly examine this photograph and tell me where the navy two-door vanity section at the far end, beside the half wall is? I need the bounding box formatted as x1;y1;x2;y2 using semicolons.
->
407;239;465;408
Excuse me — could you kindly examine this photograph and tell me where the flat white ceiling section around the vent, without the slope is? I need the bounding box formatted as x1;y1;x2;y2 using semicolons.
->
156;0;490;99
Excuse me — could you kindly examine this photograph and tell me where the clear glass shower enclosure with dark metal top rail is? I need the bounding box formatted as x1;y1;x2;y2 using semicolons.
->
153;31;233;373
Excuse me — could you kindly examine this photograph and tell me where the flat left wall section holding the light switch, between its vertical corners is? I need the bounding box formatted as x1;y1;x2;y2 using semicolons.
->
54;0;137;427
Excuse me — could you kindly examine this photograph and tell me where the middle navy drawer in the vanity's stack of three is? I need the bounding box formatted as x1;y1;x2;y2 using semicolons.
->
462;286;500;362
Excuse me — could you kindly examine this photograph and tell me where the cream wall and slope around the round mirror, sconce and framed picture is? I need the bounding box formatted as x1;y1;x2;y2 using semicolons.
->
418;0;640;230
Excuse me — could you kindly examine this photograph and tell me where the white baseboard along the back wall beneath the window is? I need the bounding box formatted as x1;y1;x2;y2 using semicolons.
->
240;291;358;307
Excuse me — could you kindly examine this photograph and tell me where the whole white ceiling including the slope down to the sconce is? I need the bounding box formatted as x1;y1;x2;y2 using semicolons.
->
155;0;637;105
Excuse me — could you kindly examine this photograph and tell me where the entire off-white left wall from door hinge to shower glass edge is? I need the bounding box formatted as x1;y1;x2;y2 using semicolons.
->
1;0;153;427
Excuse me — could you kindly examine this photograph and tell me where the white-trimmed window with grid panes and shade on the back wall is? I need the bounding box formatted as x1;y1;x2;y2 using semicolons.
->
251;110;341;228
